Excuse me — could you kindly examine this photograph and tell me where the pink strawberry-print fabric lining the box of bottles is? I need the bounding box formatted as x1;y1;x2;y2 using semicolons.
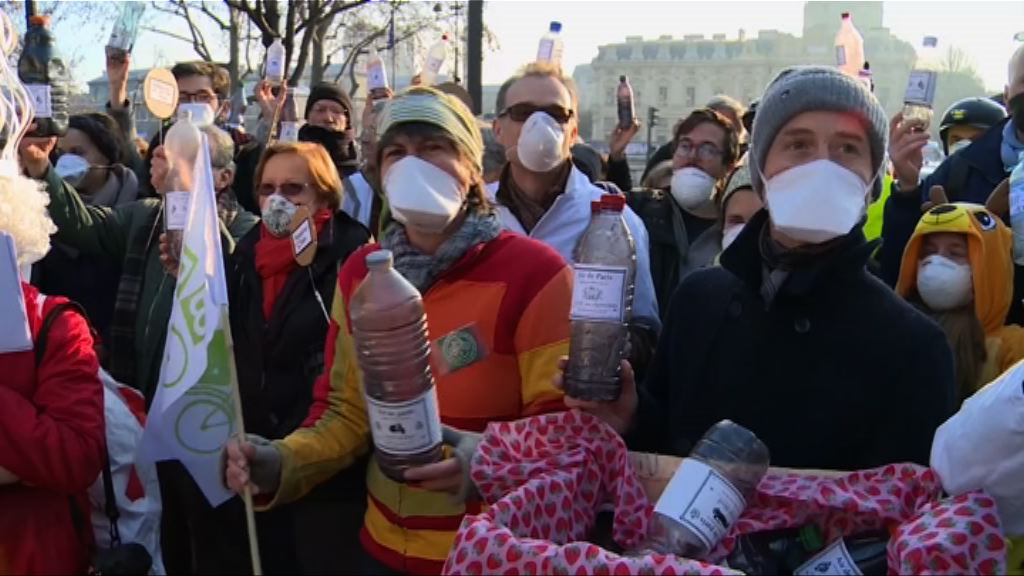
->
444;412;1007;574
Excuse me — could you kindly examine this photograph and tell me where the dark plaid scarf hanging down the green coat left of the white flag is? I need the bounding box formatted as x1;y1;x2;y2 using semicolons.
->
108;205;164;388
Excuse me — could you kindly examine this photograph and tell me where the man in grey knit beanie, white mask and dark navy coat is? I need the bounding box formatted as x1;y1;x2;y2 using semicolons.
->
566;67;955;470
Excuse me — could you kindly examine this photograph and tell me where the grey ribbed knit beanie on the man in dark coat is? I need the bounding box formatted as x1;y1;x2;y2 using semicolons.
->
750;66;889;197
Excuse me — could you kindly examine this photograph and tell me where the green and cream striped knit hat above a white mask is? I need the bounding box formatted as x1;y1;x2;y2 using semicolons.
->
377;86;483;170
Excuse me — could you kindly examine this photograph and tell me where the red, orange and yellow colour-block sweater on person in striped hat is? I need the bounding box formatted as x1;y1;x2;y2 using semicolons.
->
271;233;572;574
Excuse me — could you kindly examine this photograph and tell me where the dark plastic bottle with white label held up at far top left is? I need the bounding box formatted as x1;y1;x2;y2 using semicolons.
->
17;16;68;137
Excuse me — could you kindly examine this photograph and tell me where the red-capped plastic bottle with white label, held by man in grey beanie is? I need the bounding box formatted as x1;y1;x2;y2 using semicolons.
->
564;194;636;401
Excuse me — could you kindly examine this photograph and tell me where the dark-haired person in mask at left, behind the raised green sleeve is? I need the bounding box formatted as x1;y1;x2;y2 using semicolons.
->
32;113;138;336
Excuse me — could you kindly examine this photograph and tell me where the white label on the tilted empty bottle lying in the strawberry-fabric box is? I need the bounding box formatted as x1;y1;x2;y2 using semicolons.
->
654;458;746;548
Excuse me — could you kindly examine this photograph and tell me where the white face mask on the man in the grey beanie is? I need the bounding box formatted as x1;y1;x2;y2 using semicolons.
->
762;160;870;244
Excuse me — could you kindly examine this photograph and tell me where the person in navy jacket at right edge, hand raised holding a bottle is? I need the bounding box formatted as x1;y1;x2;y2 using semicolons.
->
880;45;1024;291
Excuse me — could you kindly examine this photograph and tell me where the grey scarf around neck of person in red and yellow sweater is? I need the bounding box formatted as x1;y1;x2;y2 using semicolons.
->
381;210;502;294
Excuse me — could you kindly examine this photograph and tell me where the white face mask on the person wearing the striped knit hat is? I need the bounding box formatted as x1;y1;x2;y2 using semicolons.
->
384;156;465;234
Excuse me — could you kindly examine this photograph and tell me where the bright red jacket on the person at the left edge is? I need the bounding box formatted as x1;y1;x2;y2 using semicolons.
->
0;284;103;574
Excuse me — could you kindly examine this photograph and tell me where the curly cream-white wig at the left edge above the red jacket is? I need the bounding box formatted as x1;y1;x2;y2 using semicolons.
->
0;173;57;266
